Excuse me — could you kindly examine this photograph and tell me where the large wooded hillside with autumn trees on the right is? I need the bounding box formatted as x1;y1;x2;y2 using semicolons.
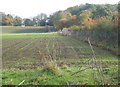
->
50;4;119;30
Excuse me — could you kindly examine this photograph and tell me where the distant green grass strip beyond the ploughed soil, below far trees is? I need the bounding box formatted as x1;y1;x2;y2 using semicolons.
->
0;26;58;39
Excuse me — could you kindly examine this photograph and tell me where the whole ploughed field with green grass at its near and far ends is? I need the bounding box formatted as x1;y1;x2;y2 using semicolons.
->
1;26;118;85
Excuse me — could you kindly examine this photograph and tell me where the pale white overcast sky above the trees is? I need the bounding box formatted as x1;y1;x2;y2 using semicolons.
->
0;0;119;18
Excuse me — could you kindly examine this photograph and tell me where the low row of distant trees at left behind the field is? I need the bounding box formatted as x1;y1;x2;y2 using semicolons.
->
0;12;47;26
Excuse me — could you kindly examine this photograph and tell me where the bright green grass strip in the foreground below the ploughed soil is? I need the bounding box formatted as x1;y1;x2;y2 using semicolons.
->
2;67;118;85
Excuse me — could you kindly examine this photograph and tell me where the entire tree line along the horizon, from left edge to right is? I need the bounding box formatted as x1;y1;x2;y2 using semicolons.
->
0;3;119;30
